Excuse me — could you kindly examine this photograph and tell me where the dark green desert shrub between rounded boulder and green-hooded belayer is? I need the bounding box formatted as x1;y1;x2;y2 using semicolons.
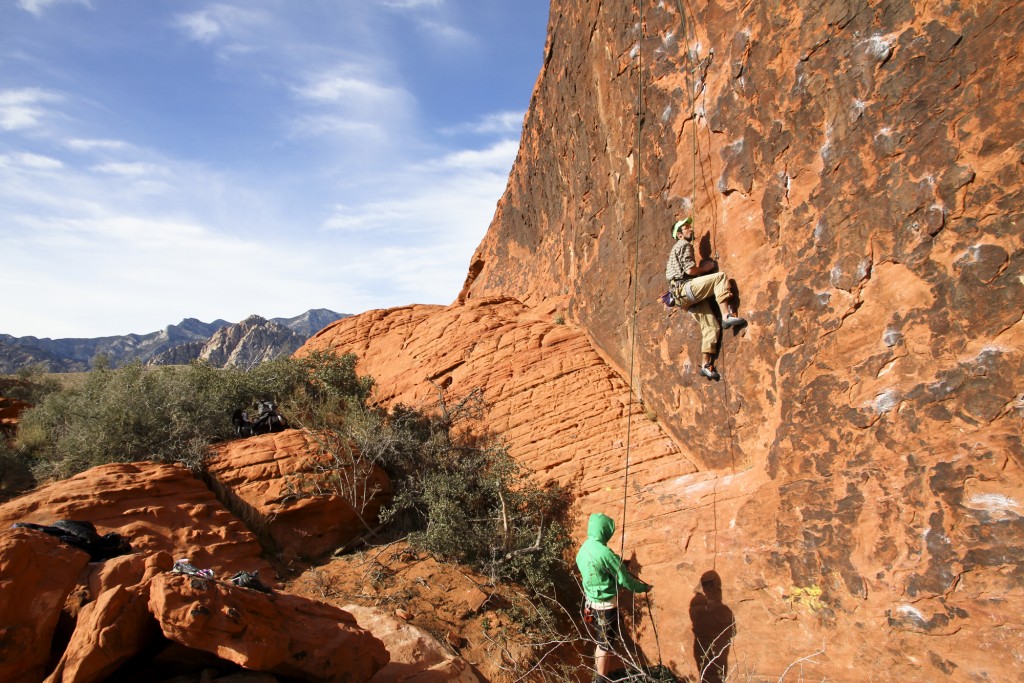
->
349;392;571;594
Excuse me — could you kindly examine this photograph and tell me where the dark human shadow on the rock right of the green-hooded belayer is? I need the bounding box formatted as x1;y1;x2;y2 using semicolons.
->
690;570;736;683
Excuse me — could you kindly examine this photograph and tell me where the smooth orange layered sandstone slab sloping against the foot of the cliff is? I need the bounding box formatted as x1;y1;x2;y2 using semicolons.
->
297;299;696;511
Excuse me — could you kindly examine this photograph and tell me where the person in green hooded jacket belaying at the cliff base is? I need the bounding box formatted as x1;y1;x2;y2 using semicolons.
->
577;512;652;683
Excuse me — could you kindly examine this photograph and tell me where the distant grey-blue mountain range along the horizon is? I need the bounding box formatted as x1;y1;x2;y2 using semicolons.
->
0;308;347;374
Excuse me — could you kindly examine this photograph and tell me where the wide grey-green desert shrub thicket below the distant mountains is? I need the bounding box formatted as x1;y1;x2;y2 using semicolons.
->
18;353;372;478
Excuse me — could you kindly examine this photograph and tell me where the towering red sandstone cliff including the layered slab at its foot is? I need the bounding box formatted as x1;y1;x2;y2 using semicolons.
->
300;0;1024;681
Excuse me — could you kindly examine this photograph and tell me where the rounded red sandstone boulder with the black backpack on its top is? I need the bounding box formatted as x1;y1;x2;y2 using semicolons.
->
207;429;391;558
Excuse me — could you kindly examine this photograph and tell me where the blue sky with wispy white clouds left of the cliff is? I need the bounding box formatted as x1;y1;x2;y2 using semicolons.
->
0;0;549;338
